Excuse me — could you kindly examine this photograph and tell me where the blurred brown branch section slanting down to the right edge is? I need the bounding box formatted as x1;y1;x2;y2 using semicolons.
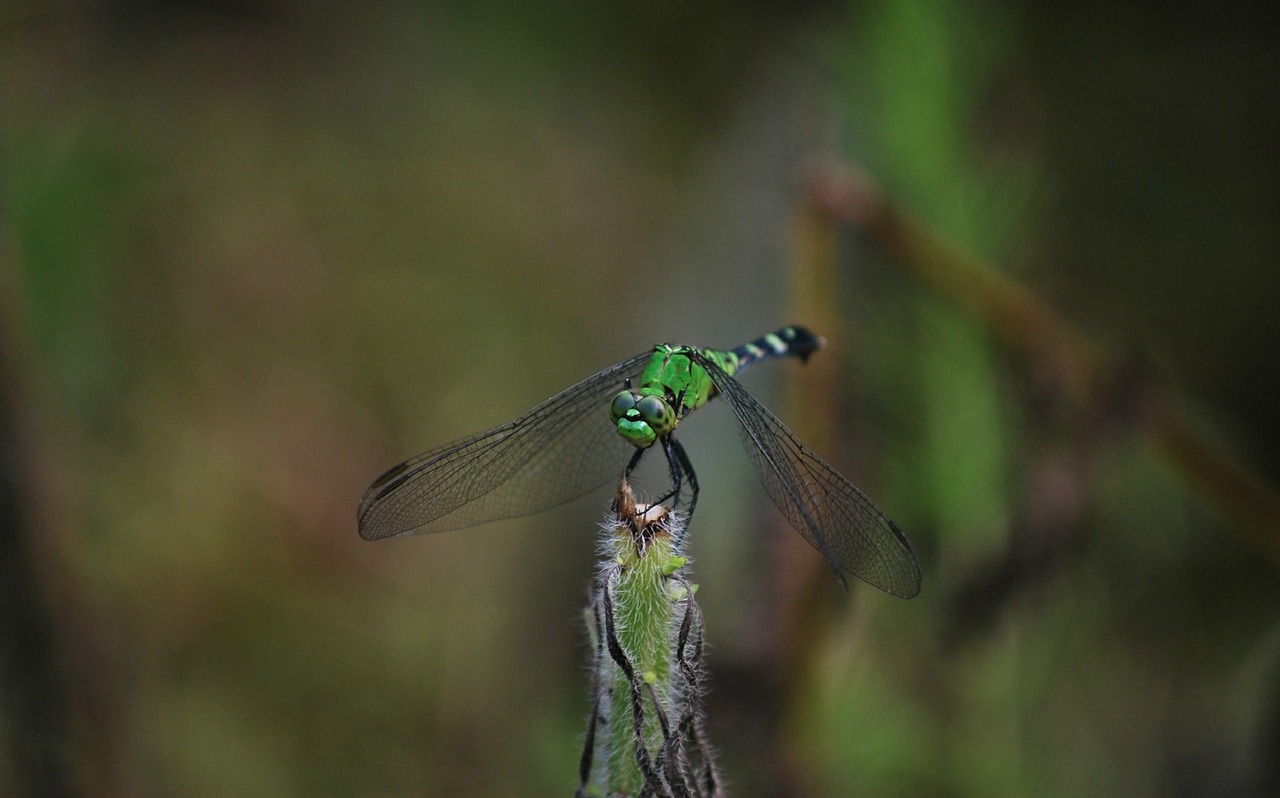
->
806;162;1280;562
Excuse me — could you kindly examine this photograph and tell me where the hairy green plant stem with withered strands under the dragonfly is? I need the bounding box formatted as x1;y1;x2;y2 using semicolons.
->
577;476;722;798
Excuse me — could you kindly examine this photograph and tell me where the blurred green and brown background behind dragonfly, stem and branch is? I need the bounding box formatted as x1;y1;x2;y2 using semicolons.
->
0;0;1280;797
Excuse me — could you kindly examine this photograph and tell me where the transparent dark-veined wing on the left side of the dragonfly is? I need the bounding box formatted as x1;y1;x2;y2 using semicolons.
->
357;351;653;541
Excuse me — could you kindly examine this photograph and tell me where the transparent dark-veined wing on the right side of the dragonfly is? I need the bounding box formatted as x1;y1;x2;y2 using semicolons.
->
698;357;920;598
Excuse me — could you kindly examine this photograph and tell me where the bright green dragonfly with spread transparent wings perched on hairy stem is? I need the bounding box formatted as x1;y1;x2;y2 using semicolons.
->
357;325;920;598
